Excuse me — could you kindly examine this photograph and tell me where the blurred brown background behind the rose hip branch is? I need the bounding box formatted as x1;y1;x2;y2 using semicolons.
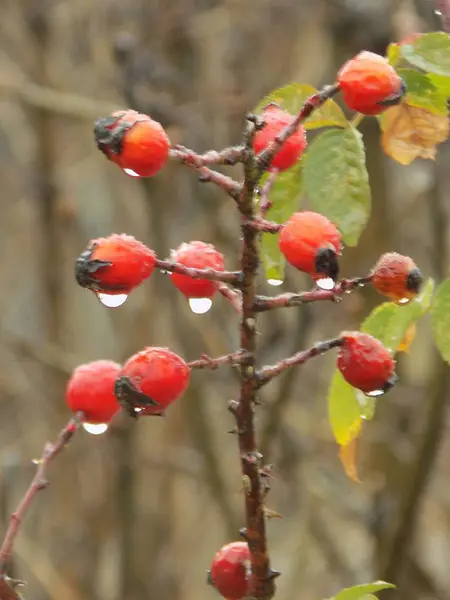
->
0;0;450;600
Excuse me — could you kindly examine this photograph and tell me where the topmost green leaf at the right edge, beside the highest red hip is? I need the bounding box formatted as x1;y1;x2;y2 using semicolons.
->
400;32;450;76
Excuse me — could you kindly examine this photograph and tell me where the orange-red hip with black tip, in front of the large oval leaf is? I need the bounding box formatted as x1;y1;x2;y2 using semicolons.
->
278;211;342;280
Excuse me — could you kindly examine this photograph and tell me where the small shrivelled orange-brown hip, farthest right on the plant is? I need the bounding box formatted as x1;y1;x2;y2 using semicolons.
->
372;252;423;304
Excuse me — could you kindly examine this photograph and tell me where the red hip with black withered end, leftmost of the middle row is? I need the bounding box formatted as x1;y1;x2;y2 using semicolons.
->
75;233;156;294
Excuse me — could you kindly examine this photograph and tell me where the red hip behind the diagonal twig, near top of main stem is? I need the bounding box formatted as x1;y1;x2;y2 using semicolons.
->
253;104;308;171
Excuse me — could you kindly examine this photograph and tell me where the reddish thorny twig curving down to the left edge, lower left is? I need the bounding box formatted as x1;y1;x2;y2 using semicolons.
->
0;412;84;578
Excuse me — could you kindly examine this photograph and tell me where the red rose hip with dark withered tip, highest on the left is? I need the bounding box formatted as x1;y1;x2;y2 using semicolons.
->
94;110;170;177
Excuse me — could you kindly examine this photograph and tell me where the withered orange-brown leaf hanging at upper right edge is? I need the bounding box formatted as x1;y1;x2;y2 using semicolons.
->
380;102;449;165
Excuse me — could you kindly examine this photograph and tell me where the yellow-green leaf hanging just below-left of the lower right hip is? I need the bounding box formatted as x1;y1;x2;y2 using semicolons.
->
328;369;361;446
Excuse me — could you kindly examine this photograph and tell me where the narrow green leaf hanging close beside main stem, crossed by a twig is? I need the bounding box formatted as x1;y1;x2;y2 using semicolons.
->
261;158;304;281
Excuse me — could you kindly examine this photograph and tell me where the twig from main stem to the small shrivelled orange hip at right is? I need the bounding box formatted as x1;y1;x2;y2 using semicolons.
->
254;275;372;312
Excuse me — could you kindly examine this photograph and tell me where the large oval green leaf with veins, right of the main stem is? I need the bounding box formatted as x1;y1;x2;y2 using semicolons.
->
304;127;371;246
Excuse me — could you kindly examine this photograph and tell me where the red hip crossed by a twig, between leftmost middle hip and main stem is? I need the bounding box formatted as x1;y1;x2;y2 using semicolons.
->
170;241;225;298
